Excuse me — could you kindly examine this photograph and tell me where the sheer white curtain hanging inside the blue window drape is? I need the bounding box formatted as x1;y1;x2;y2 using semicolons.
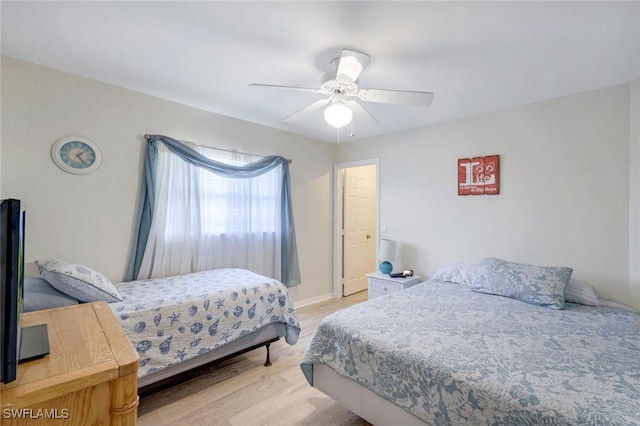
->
138;144;282;280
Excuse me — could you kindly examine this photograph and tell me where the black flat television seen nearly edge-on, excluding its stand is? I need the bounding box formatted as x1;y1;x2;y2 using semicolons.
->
0;199;25;383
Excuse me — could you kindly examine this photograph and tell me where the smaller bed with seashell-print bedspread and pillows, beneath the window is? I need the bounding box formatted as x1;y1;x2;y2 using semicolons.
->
24;259;300;390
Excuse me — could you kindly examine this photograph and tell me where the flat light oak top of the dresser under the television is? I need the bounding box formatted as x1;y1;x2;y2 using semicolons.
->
0;302;138;409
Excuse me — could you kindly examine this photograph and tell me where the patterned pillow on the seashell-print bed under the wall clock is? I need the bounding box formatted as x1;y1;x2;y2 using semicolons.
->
35;260;122;302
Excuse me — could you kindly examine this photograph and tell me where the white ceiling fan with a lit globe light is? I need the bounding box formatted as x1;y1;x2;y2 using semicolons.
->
249;49;434;128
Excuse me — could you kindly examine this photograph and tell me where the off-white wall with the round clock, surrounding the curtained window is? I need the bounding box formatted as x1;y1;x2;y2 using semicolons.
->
0;57;335;301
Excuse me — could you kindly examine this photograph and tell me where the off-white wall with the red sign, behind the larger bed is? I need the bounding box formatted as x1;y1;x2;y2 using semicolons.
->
338;85;640;306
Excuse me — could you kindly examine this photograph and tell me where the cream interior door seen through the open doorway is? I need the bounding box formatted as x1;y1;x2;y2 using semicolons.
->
342;165;377;296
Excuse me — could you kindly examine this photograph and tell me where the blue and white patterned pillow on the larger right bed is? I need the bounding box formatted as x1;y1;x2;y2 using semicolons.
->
471;257;573;309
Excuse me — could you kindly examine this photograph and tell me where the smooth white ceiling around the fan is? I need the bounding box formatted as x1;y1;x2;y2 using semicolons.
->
1;1;640;142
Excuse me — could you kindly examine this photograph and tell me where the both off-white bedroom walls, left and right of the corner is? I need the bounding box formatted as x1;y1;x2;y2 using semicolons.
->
0;57;640;307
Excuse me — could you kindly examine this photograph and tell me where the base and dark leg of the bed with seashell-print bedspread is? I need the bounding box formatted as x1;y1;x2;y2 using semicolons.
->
138;323;287;393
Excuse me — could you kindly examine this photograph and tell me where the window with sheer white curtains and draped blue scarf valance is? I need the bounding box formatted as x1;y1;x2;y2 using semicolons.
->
127;135;300;286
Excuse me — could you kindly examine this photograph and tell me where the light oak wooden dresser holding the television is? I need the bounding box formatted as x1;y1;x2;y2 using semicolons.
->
0;302;138;426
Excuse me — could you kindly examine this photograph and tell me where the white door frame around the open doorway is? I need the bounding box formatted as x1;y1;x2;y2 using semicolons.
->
333;157;380;299
